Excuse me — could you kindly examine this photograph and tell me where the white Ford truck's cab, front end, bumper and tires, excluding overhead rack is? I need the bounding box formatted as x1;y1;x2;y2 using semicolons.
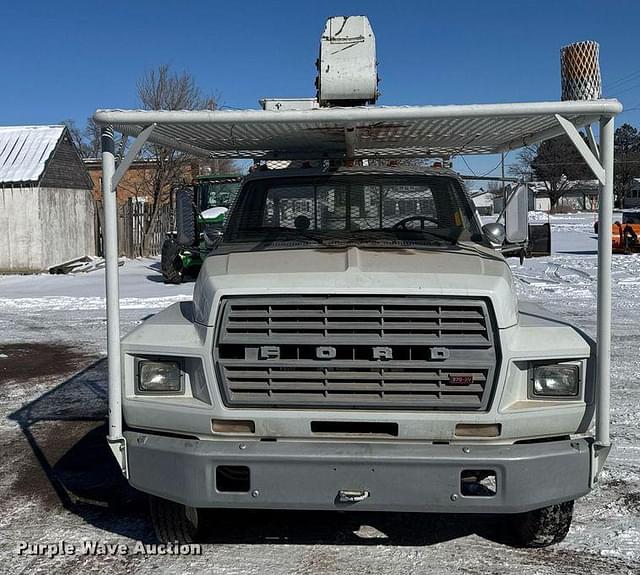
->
122;166;595;546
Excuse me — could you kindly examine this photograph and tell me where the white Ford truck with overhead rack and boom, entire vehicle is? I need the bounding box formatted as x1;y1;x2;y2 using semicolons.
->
94;16;622;546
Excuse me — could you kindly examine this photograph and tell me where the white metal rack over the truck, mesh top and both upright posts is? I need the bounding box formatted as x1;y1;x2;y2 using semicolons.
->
94;100;622;478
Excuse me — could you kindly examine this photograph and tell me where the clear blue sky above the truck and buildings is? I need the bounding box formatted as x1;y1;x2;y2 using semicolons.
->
0;0;640;173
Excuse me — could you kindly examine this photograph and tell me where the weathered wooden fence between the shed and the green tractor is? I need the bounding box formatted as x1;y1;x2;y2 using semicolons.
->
96;198;173;258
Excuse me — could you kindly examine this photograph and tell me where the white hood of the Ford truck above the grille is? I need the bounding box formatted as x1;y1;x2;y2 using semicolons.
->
193;247;517;328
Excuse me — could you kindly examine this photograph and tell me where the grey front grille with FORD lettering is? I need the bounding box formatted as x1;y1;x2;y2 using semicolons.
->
214;296;498;410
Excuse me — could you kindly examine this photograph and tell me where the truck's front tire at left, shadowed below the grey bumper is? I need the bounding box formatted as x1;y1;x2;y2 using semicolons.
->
149;495;202;543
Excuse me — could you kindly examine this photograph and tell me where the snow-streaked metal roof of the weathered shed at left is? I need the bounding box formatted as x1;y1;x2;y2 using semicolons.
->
0;126;65;183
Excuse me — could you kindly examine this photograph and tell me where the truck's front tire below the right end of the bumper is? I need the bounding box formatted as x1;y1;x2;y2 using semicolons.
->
511;501;573;548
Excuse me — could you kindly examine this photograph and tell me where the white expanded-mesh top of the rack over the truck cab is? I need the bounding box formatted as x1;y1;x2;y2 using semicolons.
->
94;100;622;159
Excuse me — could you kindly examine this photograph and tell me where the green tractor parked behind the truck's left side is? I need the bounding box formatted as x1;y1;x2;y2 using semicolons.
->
161;174;242;284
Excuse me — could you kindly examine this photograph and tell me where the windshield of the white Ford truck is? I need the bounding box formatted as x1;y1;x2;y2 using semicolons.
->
225;174;480;250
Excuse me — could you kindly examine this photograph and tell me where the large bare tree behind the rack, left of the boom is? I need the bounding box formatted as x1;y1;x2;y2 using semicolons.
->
136;64;234;255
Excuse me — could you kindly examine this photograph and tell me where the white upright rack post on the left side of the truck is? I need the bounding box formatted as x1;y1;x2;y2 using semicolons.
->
101;126;126;475
